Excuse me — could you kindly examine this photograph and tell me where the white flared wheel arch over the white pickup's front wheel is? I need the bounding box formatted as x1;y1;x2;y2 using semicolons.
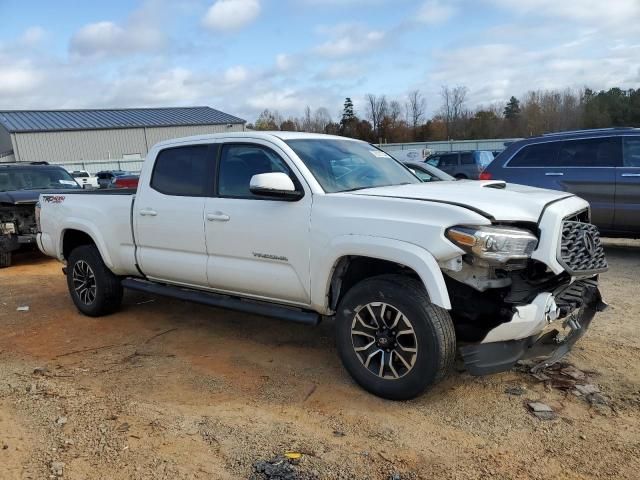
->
311;235;451;311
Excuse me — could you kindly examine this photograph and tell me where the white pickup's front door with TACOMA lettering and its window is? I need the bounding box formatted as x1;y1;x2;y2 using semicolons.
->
205;143;311;305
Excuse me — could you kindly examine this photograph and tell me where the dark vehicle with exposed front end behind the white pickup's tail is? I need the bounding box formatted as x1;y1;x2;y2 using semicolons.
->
0;163;81;268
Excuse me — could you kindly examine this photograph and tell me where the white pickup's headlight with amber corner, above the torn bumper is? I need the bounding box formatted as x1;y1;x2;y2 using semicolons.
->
446;225;538;265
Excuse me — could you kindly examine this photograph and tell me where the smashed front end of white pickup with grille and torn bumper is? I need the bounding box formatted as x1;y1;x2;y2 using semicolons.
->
444;212;607;375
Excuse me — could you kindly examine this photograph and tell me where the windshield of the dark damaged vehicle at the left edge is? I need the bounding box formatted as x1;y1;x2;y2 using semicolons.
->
0;167;80;192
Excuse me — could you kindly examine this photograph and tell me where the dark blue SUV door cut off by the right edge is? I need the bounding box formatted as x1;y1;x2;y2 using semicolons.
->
614;136;640;233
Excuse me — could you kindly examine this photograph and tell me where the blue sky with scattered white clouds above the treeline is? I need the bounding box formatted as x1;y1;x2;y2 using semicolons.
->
0;0;640;122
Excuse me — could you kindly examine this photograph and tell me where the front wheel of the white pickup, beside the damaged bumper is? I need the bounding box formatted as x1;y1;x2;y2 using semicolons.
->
336;275;456;400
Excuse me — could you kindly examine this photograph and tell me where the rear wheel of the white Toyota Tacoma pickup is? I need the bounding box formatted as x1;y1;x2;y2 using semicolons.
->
67;245;122;317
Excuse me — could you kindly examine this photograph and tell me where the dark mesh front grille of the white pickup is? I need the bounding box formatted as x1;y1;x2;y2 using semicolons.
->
558;220;608;275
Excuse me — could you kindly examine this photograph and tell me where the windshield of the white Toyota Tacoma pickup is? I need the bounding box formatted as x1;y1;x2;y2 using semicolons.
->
286;139;420;193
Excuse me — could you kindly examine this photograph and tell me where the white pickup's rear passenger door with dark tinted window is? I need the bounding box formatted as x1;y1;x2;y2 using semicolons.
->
133;145;215;287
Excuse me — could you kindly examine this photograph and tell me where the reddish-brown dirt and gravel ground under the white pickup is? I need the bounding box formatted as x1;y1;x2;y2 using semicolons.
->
0;240;640;480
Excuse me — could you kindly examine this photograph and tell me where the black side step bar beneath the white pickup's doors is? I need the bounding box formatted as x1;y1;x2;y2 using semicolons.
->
122;278;321;326
